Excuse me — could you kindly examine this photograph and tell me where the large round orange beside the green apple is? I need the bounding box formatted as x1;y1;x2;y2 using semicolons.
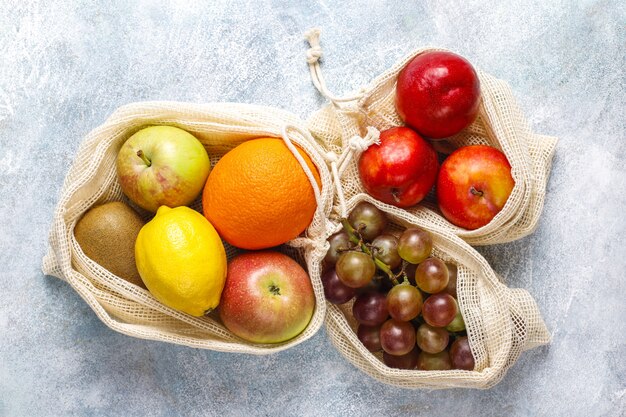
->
202;138;321;249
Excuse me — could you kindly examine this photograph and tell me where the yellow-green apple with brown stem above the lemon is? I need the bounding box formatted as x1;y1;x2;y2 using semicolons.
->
117;126;211;212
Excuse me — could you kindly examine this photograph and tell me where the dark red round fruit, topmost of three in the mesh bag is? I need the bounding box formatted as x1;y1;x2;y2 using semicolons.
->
396;51;480;139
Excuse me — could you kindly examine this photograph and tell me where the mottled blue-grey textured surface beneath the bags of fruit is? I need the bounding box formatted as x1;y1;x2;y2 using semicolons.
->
0;0;626;417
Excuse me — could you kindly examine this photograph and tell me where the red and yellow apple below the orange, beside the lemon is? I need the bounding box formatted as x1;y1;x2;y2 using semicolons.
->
219;251;315;343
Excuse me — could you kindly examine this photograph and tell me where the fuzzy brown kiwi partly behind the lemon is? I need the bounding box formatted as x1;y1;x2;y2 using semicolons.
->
74;201;146;288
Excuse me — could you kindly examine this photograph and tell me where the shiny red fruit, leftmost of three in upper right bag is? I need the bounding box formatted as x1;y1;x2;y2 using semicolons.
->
359;127;439;207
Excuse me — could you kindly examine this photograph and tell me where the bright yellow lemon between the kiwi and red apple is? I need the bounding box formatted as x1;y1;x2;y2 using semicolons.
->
135;206;226;316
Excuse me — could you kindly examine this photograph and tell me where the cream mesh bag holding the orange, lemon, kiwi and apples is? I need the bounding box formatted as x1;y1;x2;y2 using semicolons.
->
43;102;332;354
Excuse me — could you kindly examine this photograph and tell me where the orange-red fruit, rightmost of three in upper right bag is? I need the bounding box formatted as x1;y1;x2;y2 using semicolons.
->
437;145;515;230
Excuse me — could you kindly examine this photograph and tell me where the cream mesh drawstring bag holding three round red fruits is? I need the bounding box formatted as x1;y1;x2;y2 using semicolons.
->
306;30;556;245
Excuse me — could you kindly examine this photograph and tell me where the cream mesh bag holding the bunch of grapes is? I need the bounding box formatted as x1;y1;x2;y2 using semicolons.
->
326;194;550;389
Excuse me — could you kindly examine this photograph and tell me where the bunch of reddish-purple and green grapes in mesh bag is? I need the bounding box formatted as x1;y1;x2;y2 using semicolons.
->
322;202;474;370
